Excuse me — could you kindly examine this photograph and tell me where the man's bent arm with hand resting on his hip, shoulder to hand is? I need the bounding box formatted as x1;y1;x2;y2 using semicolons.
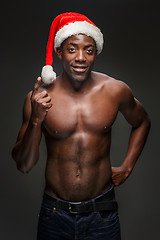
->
112;83;150;186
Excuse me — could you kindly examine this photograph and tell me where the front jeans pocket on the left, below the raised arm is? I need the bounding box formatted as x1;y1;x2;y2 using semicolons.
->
39;204;56;220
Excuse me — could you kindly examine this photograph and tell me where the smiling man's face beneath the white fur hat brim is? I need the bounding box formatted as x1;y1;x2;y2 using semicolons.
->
57;34;97;82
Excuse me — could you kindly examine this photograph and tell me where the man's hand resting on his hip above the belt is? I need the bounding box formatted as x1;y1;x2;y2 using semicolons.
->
112;166;130;186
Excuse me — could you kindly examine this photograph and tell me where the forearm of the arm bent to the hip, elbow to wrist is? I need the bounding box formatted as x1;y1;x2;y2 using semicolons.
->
122;117;150;173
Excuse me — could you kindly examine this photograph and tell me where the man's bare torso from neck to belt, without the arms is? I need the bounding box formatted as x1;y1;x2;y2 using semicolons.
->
43;73;119;201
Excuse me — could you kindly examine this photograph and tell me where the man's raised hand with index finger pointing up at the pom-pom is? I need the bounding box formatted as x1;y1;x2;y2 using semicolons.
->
31;77;52;125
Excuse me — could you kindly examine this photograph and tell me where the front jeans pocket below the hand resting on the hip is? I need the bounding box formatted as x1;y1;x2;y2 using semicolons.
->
97;211;119;223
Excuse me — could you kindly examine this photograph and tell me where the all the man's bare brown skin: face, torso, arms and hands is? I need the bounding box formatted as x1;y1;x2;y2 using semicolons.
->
12;34;150;201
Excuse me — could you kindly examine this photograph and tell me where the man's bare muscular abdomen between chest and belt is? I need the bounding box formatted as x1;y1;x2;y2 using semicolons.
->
45;132;111;201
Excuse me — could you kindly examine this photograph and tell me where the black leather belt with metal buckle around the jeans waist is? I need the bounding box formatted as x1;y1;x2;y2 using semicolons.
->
43;189;118;214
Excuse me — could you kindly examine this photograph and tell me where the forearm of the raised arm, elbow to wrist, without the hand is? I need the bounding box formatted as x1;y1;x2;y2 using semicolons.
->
12;120;41;173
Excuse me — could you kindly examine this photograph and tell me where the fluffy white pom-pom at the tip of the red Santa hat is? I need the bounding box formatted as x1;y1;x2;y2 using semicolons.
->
41;65;56;84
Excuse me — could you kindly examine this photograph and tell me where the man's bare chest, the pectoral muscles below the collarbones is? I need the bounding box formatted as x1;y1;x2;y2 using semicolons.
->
44;90;118;139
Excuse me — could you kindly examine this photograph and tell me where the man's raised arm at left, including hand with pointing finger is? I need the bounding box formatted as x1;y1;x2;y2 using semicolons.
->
12;78;52;173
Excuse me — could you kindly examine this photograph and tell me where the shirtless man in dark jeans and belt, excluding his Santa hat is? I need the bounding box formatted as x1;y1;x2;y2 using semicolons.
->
12;12;150;240
